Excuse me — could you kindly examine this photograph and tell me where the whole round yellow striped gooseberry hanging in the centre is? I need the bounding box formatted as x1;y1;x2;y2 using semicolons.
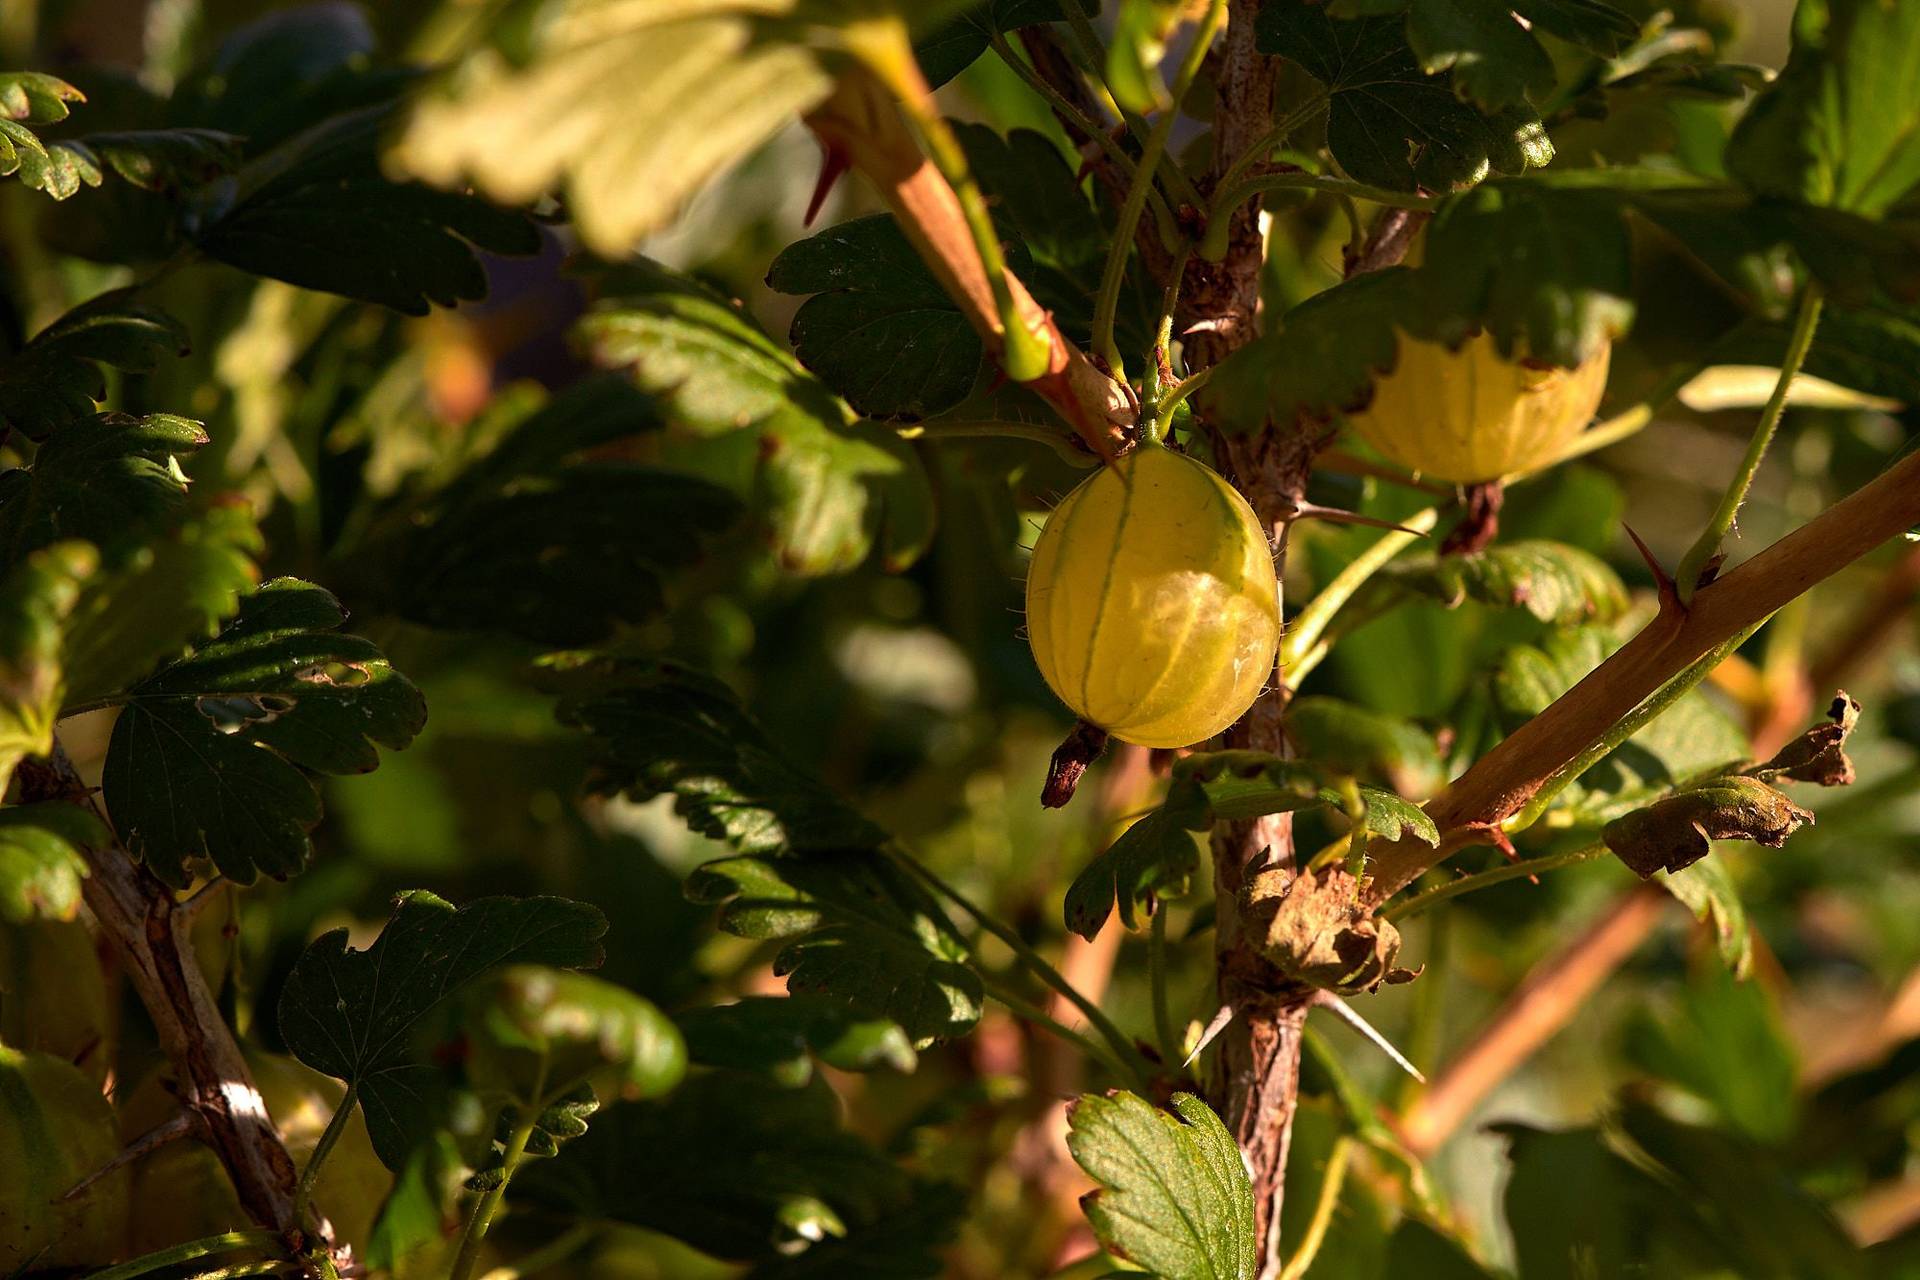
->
1027;443;1281;747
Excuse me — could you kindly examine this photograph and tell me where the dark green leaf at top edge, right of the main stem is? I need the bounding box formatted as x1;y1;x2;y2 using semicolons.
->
1256;0;1553;192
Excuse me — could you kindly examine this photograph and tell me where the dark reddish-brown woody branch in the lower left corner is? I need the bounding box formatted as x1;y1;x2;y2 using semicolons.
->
19;743;312;1247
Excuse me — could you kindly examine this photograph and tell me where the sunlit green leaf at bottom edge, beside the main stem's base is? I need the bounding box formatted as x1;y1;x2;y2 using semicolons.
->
1068;1092;1256;1280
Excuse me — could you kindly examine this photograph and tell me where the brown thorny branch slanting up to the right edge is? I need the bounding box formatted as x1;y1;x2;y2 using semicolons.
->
1367;445;1920;906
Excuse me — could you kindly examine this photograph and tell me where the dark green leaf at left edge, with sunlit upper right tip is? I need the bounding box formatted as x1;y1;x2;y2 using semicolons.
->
0;413;207;564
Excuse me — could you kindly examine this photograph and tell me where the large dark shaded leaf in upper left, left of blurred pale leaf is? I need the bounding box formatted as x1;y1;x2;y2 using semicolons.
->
194;104;540;315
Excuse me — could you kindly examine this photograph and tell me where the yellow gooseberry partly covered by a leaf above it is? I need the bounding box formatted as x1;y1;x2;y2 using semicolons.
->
1348;332;1611;484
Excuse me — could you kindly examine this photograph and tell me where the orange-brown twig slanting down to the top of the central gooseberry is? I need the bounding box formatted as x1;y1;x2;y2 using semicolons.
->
806;71;1137;457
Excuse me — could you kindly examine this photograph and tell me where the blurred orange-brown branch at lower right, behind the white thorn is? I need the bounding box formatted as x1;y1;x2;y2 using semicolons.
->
1398;885;1670;1157
